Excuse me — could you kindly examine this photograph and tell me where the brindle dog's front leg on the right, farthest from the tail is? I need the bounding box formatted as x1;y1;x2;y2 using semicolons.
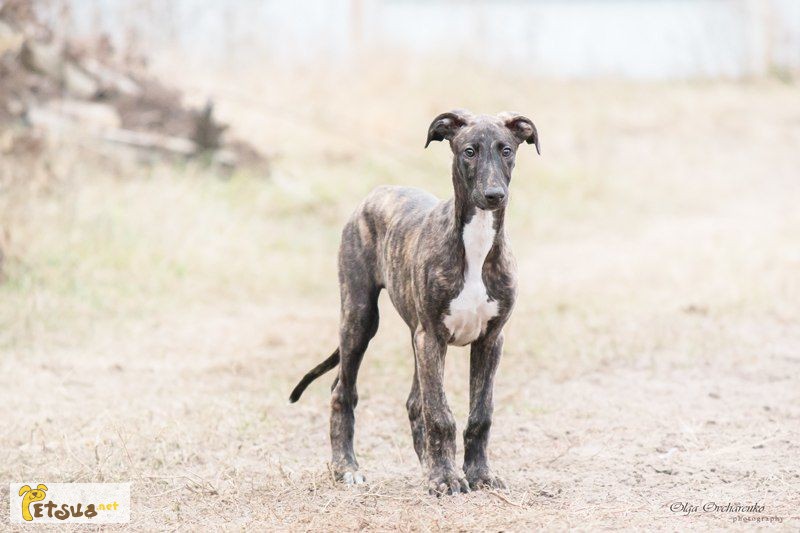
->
464;333;505;489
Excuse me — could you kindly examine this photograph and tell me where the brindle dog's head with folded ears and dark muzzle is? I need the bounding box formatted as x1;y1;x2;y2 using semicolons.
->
425;110;541;210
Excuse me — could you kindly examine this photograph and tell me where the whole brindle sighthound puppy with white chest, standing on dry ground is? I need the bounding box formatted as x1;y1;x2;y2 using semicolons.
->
290;111;539;494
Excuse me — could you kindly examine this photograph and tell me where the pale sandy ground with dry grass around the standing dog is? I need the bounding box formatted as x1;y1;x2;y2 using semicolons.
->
0;57;800;531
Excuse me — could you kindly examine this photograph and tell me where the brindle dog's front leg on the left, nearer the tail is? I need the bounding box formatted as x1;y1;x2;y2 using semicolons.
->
414;328;469;495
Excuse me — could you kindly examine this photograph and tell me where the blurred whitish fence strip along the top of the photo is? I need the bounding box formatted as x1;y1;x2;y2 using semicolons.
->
62;0;800;79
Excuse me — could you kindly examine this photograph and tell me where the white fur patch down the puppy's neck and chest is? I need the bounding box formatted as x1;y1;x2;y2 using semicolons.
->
444;209;497;346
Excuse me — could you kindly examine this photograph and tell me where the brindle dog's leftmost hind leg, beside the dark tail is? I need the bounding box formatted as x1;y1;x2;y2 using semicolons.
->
331;272;380;484
